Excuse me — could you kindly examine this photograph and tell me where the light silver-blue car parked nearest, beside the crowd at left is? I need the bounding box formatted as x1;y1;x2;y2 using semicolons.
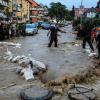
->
25;24;38;35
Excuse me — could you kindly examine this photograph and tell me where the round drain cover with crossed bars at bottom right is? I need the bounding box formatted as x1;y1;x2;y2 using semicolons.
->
68;85;95;100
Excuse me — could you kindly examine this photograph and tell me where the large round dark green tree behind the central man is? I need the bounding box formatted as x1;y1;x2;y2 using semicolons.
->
48;2;67;23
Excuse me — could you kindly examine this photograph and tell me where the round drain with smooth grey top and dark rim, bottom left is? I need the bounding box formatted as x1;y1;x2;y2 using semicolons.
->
20;86;53;100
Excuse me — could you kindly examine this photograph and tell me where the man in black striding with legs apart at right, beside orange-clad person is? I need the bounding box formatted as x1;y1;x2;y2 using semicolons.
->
81;25;94;51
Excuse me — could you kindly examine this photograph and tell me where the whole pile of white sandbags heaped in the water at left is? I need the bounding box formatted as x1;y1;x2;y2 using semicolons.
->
4;50;47;80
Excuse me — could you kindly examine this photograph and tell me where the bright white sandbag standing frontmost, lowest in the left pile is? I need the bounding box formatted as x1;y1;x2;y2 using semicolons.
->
21;67;34;81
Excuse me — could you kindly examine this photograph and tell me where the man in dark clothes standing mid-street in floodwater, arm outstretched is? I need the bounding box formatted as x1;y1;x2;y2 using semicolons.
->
47;24;66;47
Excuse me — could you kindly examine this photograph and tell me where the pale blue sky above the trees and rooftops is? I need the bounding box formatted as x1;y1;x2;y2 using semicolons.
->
35;0;99;9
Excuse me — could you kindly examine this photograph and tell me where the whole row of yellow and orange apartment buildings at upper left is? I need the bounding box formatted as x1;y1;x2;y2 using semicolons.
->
0;0;48;23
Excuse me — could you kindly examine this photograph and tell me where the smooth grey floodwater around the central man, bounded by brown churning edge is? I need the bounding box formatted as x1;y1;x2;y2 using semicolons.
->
0;26;91;82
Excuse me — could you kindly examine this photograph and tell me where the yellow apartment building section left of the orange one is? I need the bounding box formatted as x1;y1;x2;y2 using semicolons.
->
9;0;33;23
